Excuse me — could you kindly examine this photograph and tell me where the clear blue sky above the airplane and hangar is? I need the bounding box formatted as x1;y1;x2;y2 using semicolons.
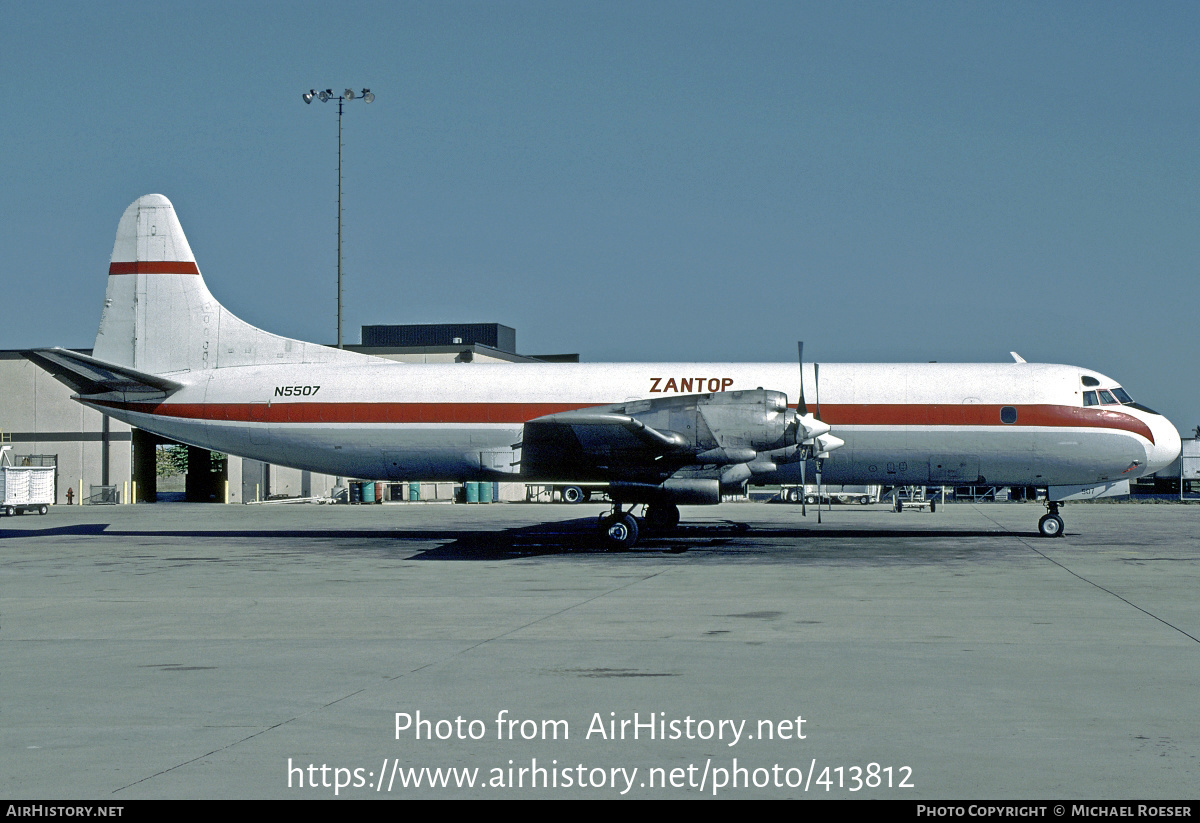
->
0;0;1200;433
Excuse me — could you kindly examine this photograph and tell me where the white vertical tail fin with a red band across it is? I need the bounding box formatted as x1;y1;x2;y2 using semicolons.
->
92;194;371;374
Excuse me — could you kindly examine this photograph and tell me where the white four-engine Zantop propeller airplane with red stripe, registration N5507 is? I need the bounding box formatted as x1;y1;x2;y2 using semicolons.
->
26;194;1181;547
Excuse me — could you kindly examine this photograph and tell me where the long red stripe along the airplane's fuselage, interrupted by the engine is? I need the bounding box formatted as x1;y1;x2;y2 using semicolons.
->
84;401;1154;443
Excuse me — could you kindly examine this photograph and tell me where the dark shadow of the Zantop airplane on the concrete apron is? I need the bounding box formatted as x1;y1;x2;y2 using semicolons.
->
0;517;1036;560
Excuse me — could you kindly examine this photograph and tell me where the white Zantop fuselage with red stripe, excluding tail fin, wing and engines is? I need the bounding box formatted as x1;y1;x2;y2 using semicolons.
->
84;360;1178;486
